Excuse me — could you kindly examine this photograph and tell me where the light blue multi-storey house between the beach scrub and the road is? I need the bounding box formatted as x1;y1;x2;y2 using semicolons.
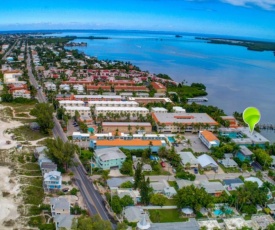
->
43;171;62;191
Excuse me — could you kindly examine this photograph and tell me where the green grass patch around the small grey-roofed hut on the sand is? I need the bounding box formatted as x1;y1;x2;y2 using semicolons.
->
12;125;49;141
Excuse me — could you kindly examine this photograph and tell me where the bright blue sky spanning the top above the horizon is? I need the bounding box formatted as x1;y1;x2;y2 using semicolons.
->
0;0;275;39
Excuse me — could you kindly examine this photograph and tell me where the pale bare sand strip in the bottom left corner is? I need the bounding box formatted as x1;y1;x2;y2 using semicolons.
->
0;166;19;227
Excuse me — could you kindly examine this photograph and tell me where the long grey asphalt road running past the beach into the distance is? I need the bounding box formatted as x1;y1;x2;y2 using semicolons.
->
24;45;114;228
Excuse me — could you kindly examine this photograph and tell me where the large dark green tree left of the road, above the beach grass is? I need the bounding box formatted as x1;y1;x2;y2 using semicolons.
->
30;103;54;133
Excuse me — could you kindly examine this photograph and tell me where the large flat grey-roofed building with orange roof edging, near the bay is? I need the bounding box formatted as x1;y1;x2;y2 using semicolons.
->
152;113;218;133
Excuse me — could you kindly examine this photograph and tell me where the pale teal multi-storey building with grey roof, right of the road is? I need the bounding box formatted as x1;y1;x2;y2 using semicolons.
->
94;147;126;170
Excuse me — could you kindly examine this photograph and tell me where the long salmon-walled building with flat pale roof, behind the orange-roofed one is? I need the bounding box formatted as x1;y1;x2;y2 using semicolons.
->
102;122;152;133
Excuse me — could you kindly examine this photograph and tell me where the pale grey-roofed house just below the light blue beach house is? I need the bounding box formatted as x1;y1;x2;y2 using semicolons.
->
50;197;70;217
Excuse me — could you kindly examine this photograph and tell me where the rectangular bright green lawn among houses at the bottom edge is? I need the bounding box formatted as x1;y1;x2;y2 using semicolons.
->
148;209;188;223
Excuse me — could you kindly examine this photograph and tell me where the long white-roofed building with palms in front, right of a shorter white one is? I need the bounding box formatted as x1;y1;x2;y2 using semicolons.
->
94;107;149;119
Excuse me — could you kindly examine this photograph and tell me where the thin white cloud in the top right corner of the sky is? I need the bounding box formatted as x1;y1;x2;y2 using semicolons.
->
221;0;275;10
